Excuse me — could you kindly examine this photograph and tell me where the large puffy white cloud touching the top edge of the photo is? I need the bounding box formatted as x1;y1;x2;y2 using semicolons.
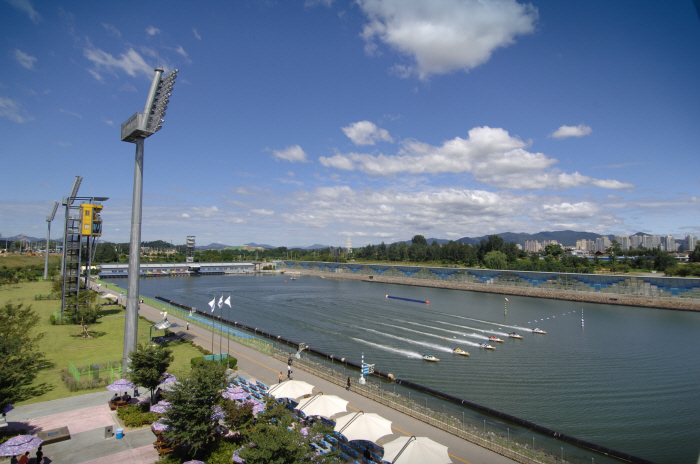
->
357;0;538;79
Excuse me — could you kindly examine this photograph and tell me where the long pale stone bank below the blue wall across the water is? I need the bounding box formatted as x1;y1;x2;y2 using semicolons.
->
293;269;700;311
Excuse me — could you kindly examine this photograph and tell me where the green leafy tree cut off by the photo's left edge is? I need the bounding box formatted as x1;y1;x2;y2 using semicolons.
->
0;302;53;411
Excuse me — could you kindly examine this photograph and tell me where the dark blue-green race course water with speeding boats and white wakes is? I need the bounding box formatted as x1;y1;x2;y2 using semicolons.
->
105;276;700;463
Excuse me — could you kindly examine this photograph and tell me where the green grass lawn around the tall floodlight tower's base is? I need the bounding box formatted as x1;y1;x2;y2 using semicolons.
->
0;282;202;404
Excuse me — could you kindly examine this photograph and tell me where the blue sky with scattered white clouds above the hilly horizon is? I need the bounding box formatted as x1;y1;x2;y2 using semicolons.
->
0;0;700;246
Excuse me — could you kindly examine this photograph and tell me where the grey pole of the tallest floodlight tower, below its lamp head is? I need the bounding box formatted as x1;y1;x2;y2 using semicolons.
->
122;138;144;369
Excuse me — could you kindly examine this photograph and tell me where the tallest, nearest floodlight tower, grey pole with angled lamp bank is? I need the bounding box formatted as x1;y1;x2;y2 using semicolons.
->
121;68;178;368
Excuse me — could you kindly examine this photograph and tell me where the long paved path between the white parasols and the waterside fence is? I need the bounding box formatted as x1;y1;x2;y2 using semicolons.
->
94;280;515;464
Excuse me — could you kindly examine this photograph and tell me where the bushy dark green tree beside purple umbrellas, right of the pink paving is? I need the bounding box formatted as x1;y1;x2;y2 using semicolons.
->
163;362;226;457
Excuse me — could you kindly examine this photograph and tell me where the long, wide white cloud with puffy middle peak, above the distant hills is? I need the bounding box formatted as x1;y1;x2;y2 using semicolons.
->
319;127;633;190
